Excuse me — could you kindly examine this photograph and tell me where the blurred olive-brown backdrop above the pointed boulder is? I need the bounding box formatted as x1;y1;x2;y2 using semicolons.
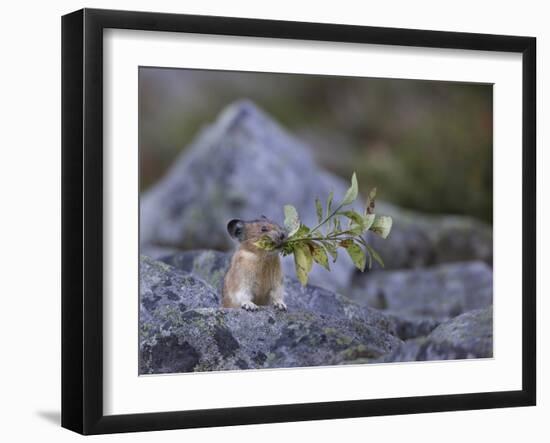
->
139;68;493;223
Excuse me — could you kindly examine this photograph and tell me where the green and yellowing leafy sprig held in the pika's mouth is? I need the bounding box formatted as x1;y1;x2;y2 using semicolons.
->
256;173;392;286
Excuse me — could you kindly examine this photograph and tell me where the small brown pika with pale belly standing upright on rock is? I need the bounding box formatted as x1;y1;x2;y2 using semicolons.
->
222;217;287;311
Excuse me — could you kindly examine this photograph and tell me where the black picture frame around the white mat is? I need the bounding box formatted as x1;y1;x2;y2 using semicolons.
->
61;9;536;434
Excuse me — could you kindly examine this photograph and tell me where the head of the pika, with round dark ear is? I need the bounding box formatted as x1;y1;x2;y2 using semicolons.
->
227;217;287;253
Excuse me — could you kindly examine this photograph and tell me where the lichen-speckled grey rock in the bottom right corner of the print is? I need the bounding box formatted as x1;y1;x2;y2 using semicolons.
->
378;306;493;363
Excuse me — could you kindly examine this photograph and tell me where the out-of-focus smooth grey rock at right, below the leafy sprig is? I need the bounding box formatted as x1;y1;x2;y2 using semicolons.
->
351;261;493;322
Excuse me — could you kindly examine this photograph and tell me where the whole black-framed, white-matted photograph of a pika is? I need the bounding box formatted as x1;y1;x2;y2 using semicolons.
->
62;9;536;434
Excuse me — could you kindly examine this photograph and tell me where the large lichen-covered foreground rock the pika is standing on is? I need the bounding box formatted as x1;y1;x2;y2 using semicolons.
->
140;254;402;374
